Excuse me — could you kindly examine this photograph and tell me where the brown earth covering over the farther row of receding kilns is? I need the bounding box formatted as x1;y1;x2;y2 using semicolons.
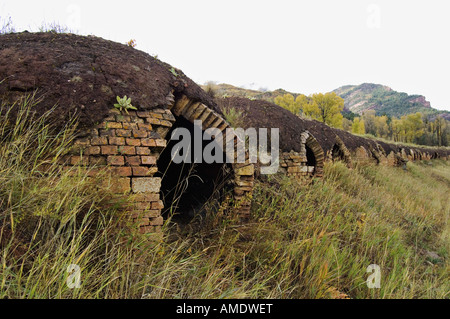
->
215;97;450;157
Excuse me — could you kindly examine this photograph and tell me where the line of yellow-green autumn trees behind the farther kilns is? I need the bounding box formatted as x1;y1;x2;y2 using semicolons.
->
274;92;450;146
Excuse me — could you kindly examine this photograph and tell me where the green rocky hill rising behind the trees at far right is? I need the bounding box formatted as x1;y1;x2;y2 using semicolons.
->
333;83;450;120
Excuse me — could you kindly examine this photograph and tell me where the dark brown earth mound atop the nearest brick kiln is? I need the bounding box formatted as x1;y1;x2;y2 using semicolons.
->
0;32;214;131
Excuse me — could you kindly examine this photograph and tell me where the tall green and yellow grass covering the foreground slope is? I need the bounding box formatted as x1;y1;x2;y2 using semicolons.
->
0;97;450;298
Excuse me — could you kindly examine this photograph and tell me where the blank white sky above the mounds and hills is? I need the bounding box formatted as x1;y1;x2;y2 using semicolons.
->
0;0;450;110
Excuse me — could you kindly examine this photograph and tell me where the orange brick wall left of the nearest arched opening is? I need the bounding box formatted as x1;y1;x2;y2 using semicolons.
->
65;109;175;233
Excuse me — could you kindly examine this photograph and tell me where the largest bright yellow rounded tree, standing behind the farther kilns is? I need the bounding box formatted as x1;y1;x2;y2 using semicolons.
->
299;92;344;128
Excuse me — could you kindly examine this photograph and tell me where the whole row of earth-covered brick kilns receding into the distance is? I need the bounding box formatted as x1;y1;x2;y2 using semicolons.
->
0;32;450;238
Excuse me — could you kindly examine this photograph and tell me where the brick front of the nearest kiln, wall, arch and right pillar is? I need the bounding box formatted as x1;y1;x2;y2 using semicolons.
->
64;96;254;233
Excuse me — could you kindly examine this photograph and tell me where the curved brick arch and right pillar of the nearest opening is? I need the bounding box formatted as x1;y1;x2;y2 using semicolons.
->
170;95;254;218
